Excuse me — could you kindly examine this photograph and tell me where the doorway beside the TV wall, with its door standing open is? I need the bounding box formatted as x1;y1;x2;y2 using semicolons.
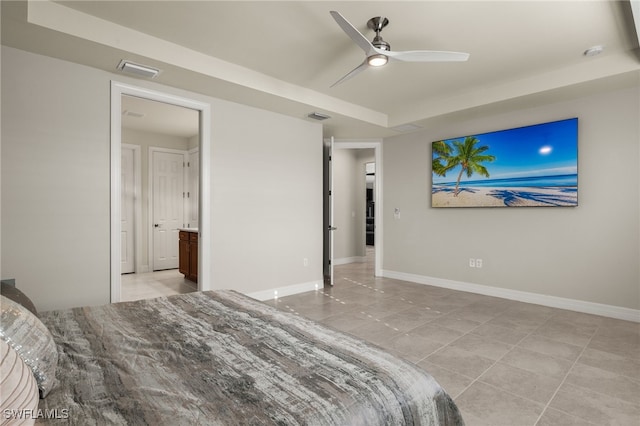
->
324;140;383;285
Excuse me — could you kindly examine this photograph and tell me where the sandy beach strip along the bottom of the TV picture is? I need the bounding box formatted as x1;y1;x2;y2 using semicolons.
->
431;186;578;207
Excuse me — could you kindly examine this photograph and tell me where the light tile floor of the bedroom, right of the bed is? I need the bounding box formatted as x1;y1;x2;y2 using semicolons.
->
267;251;640;426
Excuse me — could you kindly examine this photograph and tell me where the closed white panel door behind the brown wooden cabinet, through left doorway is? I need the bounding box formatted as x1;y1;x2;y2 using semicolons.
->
153;151;185;271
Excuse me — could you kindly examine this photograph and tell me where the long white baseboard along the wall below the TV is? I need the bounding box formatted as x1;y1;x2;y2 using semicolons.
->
382;270;640;322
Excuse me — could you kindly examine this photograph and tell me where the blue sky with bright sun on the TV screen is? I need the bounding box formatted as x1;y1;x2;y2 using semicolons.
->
433;118;578;183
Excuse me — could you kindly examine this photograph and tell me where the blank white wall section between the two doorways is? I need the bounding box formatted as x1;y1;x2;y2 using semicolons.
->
212;97;323;295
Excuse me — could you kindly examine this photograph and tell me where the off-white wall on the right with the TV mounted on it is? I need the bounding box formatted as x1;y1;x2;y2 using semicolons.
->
383;87;640;309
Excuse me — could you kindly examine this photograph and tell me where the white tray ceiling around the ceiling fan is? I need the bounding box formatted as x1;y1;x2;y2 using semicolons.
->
2;0;640;138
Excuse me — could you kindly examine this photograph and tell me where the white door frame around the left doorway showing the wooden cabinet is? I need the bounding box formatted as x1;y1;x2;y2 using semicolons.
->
110;80;213;303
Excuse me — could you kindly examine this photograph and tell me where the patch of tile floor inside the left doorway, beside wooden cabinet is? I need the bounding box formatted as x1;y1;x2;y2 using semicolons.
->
120;269;198;302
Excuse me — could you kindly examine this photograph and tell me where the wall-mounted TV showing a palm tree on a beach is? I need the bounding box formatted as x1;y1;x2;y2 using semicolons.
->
431;118;578;207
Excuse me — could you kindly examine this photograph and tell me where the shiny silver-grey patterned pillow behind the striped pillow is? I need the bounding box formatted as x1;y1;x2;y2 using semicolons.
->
0;296;58;398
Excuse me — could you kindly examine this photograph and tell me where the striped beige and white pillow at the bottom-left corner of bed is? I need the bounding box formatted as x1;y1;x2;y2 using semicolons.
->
0;340;38;426
